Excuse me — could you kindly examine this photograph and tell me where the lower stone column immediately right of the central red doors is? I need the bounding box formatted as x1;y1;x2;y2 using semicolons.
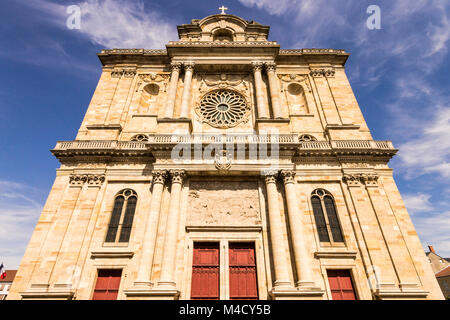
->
265;171;291;289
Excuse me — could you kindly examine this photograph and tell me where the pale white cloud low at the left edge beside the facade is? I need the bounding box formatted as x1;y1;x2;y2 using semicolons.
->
0;180;42;269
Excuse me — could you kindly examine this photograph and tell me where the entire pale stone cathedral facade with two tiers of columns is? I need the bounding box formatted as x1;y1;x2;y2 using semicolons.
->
8;13;443;300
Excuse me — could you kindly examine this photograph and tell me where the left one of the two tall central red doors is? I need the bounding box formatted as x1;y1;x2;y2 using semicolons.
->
191;242;219;300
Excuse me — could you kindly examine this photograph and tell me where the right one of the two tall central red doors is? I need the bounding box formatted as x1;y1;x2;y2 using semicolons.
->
230;242;258;300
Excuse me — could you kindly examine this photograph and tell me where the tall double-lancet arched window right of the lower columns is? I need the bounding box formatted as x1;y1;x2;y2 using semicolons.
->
311;189;344;244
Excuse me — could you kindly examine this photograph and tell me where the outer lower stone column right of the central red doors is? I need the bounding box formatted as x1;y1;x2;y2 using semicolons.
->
281;170;314;287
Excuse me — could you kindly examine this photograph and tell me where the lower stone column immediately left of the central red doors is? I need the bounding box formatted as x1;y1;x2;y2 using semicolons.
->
158;170;186;289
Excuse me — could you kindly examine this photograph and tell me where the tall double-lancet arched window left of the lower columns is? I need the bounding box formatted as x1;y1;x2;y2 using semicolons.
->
105;189;137;243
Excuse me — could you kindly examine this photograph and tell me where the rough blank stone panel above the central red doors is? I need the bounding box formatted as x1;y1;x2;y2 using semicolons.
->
186;181;261;226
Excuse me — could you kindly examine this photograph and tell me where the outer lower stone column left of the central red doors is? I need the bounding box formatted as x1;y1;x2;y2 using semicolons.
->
134;170;167;287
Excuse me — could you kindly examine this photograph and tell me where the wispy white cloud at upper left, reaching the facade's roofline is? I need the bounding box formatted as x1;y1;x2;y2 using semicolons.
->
22;0;178;48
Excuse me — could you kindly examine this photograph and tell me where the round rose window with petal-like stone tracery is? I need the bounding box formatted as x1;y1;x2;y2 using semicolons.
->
198;90;248;128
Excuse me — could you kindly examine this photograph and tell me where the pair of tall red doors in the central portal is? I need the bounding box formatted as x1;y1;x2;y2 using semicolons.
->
191;243;258;300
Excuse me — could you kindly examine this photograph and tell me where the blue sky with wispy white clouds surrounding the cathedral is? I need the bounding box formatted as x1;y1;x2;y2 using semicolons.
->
0;0;450;268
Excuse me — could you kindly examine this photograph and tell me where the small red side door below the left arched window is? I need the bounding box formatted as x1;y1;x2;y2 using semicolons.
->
92;269;122;300
